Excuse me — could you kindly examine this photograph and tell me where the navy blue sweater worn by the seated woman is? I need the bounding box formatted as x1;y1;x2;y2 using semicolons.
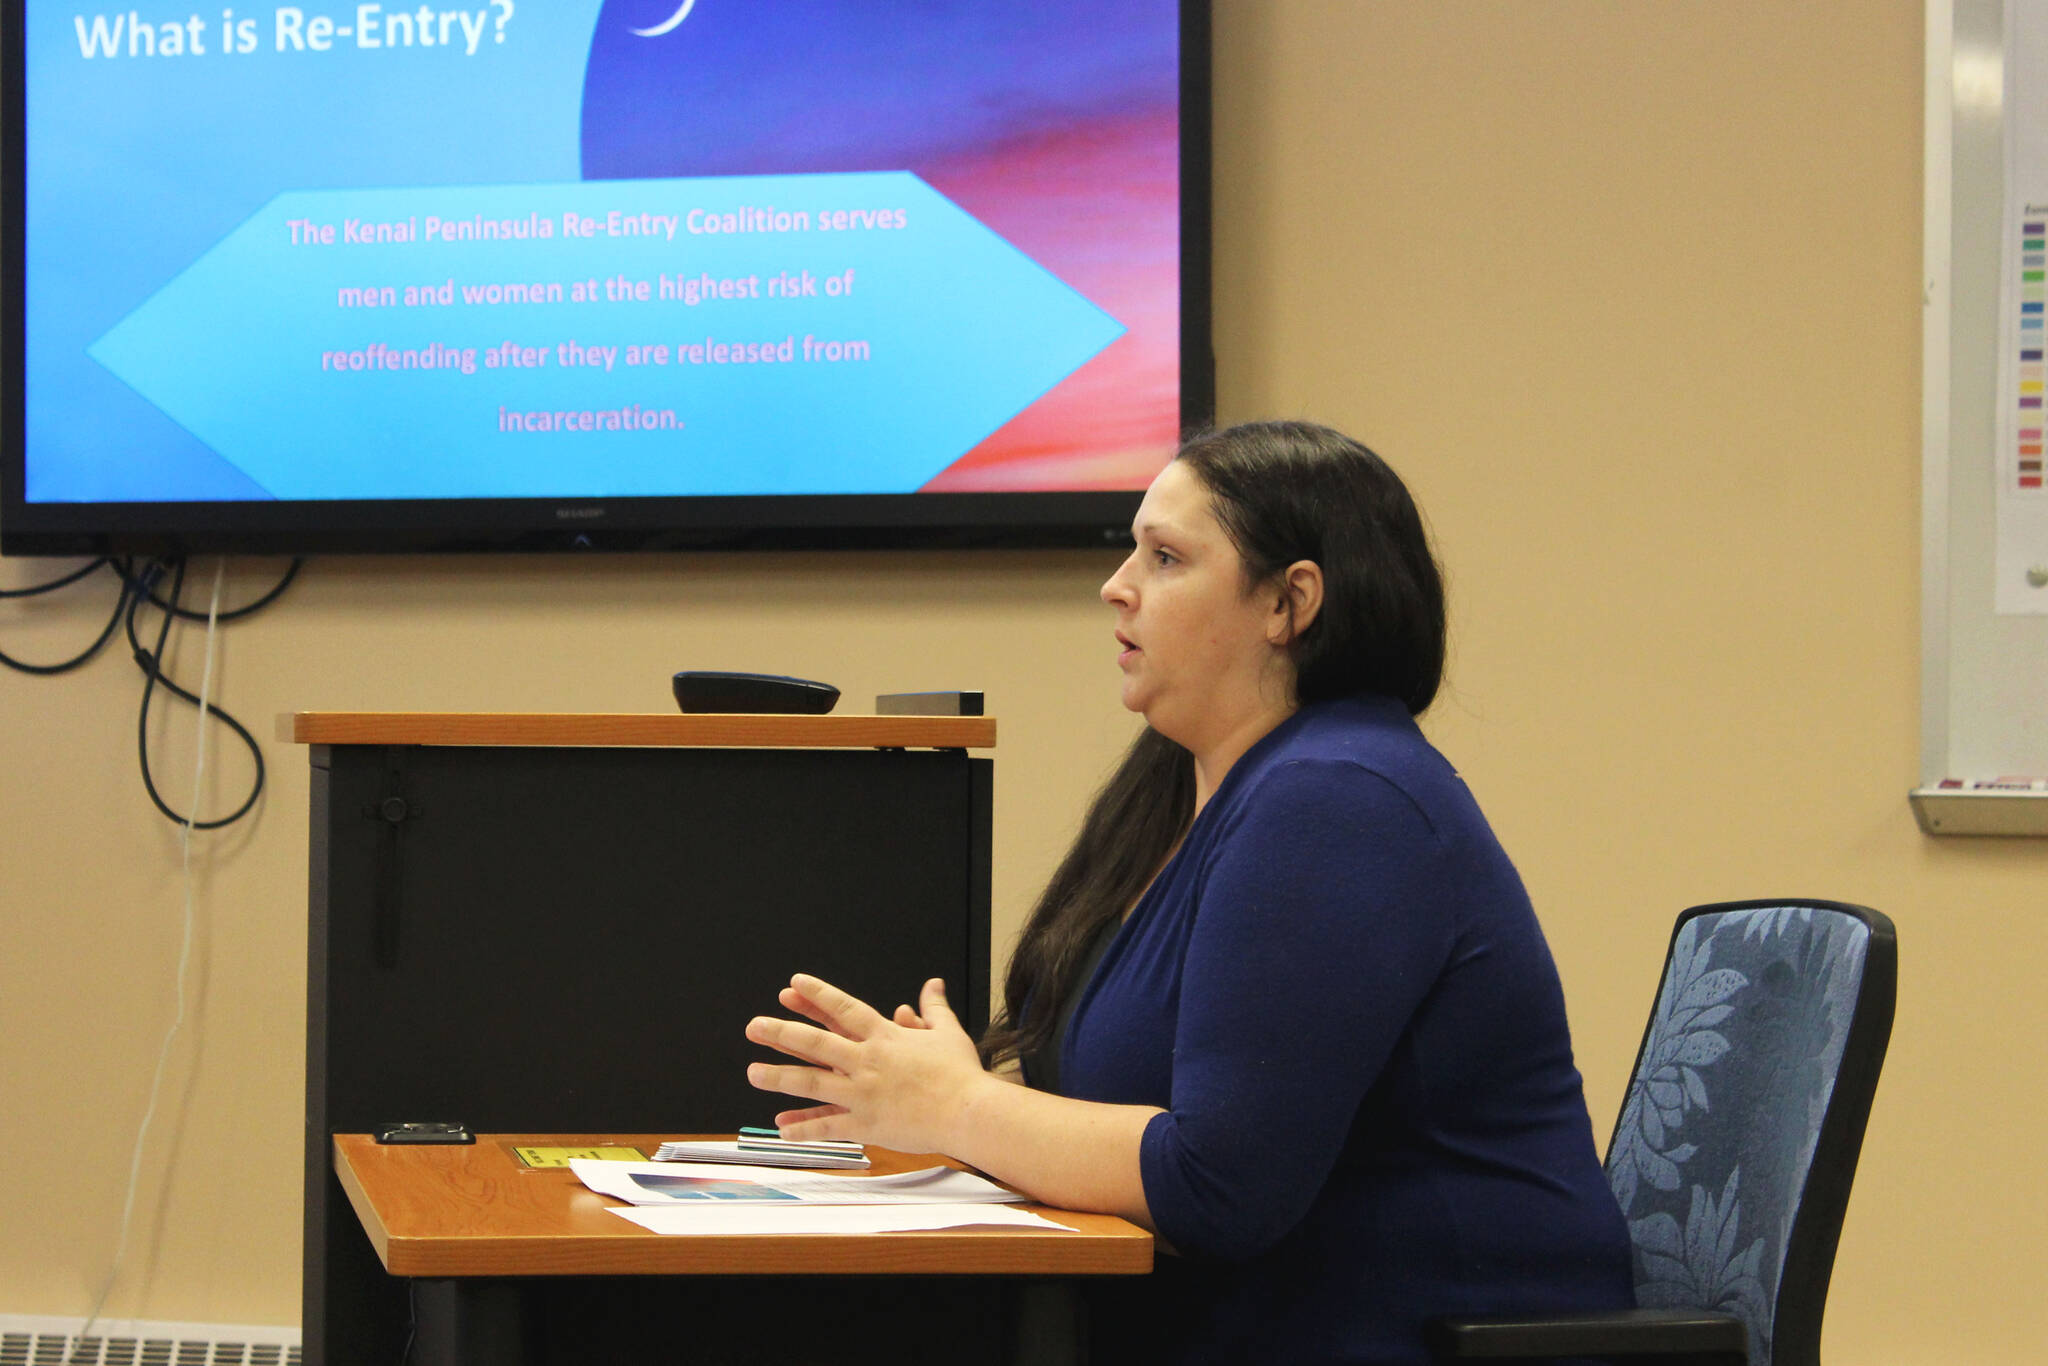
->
1059;698;1632;1362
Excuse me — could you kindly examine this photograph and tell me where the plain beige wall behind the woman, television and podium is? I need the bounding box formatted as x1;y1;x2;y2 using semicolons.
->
0;0;2048;1364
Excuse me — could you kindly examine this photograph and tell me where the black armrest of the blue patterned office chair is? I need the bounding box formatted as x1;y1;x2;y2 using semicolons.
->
1427;1309;1749;1366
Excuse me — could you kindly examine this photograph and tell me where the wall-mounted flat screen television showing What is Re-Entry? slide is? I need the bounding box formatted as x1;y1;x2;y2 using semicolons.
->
0;0;1212;555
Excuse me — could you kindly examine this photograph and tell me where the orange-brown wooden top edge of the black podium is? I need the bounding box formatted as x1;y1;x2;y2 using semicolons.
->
276;711;995;750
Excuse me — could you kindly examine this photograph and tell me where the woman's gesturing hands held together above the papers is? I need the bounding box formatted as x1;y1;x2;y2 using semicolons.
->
748;975;1001;1153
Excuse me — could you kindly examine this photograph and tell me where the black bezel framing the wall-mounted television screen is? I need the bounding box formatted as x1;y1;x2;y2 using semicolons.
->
0;0;1217;555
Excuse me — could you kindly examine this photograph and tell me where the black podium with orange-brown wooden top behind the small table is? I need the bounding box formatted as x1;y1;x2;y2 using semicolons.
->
281;713;995;1366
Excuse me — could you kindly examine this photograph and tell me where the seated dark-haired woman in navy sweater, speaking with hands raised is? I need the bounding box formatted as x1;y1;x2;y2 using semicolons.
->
748;422;1632;1362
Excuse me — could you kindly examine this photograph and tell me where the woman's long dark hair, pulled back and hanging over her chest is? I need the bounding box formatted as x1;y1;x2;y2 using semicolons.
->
981;422;1444;1065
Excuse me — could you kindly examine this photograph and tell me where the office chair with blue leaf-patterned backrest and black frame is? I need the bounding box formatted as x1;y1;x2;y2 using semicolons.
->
1430;901;1898;1366
